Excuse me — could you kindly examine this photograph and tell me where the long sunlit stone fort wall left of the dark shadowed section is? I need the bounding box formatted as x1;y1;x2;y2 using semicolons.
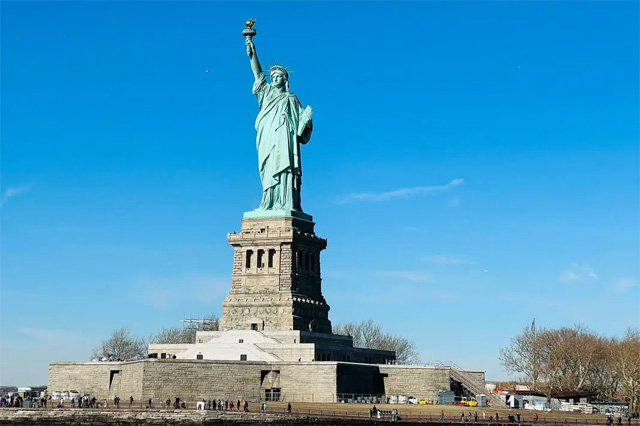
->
49;359;336;404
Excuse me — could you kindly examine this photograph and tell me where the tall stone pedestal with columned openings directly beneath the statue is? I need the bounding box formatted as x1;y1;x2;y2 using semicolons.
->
220;216;331;333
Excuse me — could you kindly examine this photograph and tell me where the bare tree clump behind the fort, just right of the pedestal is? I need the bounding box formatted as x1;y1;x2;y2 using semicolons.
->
333;319;419;364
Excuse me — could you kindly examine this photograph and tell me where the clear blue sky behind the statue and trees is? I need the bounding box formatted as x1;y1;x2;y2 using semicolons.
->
0;1;640;385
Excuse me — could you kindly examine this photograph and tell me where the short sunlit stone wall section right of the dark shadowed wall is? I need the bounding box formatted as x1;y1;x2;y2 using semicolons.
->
380;365;451;401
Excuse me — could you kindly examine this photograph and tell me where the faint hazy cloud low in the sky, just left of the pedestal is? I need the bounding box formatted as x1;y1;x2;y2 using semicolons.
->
135;275;231;307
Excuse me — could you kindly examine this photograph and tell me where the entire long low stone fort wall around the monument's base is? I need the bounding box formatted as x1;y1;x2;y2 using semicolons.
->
49;359;470;404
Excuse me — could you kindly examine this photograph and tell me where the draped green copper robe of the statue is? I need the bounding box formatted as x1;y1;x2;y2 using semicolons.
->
253;74;313;212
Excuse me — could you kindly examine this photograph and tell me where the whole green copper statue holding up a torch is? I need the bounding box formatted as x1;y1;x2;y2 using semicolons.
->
243;21;313;217
